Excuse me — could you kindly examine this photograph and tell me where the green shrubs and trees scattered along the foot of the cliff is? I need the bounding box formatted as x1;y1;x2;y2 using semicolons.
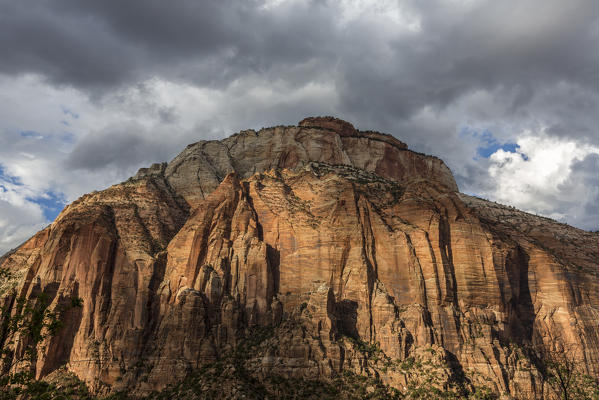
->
0;270;599;400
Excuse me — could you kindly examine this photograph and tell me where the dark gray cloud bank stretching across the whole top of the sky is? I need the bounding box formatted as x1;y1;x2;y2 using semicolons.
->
0;0;599;137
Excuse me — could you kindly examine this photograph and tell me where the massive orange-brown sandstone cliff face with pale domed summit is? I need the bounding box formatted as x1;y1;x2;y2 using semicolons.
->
0;118;599;398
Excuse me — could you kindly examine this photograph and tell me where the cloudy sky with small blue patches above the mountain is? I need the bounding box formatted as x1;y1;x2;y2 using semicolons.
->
0;0;599;254
